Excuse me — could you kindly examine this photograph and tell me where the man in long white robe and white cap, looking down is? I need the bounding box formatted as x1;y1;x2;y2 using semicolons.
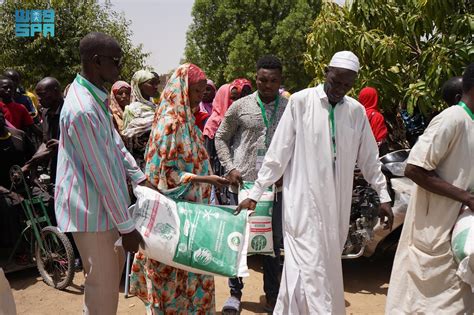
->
237;51;393;315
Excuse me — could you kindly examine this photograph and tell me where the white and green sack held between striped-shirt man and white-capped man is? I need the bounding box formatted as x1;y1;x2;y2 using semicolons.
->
131;186;248;277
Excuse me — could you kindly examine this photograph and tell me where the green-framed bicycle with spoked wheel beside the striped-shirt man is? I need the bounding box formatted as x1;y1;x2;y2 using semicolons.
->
7;165;74;290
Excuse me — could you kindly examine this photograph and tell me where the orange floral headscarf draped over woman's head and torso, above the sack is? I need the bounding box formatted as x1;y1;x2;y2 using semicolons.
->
145;64;210;202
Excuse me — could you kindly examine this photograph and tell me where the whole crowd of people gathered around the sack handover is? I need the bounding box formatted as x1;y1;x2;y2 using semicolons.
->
0;29;474;314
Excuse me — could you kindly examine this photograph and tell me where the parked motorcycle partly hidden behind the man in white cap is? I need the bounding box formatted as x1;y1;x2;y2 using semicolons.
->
342;150;413;259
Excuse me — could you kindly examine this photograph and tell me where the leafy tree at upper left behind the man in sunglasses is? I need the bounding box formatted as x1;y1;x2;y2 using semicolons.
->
0;0;149;87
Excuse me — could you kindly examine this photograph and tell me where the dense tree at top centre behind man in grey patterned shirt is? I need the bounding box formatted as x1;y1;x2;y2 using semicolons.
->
185;0;321;91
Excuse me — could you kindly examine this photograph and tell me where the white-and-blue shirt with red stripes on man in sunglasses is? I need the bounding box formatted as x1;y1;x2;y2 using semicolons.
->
55;74;146;233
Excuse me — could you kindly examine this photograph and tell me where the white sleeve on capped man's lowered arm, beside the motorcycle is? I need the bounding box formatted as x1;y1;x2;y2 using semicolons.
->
357;112;392;203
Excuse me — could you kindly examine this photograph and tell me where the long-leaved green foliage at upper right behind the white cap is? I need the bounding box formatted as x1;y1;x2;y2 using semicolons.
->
305;0;474;116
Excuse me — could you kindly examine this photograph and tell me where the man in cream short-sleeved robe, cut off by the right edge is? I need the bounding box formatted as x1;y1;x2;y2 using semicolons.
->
386;63;474;314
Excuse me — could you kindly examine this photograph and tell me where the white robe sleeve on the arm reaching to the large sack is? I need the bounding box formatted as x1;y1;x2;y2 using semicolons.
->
249;98;296;201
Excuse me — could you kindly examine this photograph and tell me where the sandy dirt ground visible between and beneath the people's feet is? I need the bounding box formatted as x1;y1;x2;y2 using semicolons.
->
7;250;394;315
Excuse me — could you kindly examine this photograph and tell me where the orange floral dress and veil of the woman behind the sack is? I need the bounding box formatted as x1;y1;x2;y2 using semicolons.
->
131;64;215;314
